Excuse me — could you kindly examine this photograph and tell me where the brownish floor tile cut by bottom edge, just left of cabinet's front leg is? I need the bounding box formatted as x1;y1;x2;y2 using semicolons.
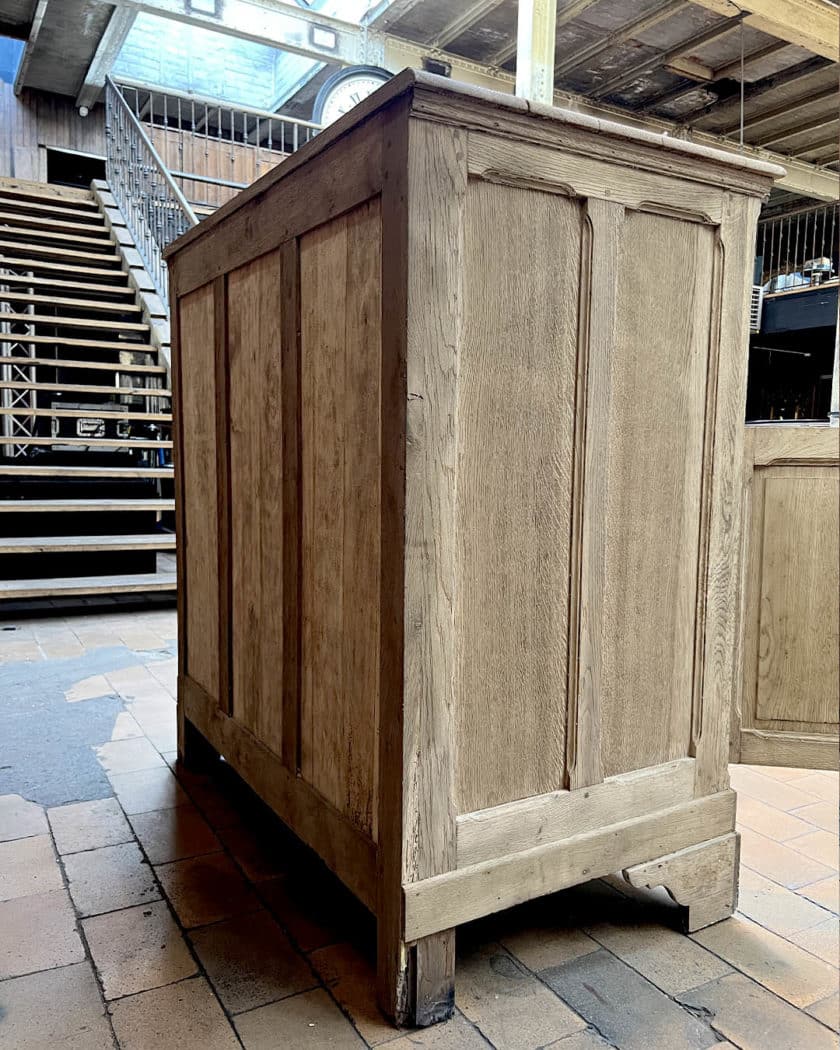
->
234;988;363;1050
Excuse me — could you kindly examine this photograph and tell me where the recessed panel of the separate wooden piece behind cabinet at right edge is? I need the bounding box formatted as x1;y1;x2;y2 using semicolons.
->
754;466;840;726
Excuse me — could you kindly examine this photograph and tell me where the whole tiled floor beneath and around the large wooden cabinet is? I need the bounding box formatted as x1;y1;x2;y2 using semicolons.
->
0;610;840;1050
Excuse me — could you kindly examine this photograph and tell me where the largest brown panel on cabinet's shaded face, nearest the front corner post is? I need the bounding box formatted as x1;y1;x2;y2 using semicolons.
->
300;197;381;837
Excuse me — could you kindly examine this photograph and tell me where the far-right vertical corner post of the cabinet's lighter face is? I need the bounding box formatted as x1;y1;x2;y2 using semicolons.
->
692;193;760;795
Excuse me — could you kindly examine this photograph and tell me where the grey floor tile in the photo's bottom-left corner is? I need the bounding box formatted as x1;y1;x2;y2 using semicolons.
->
0;962;113;1050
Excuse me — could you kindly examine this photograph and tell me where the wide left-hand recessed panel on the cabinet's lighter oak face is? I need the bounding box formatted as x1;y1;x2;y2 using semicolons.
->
456;181;582;813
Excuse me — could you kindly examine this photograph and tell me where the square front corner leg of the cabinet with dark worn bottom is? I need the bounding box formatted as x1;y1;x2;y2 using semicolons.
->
378;929;455;1028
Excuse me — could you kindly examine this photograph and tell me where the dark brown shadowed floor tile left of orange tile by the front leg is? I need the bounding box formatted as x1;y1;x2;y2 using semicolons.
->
190;911;318;1013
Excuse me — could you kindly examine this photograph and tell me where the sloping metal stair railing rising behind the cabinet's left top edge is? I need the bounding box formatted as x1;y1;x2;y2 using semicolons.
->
105;78;197;303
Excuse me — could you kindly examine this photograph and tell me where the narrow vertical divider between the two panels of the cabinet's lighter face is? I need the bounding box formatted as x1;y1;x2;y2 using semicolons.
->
566;197;624;789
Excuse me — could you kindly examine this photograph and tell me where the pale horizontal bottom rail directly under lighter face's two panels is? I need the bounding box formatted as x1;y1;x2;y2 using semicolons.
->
458;758;694;868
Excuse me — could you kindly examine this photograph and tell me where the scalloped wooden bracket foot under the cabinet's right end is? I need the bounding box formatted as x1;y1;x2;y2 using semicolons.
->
623;832;740;933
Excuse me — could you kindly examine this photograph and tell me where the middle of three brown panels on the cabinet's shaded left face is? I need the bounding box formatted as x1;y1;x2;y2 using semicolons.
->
228;252;285;755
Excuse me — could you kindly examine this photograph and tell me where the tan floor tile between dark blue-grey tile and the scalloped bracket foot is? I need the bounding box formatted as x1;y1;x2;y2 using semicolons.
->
587;922;732;996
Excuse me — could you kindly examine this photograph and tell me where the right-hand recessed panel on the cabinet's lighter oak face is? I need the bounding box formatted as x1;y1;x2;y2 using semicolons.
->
602;211;715;776
